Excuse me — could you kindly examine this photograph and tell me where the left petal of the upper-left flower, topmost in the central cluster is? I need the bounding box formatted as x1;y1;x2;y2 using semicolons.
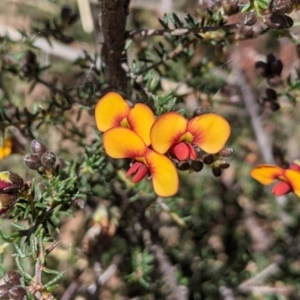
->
95;92;130;132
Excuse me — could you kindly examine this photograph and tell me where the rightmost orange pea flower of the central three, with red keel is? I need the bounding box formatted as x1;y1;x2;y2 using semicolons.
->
150;112;230;161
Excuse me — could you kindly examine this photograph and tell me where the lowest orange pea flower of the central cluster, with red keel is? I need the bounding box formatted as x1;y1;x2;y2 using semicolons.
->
103;127;178;197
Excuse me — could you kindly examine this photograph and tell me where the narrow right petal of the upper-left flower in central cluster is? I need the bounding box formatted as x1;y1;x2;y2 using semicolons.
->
127;103;155;145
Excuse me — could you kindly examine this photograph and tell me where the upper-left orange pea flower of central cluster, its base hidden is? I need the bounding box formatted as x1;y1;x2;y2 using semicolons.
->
95;92;155;145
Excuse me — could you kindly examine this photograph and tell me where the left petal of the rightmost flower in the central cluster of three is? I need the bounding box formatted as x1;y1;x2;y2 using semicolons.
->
150;112;187;154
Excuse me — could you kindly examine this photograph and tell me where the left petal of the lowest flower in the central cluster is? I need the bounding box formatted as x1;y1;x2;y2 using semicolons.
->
103;127;148;158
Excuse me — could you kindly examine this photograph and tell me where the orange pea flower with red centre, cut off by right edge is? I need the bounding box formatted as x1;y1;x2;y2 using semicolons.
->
250;162;300;197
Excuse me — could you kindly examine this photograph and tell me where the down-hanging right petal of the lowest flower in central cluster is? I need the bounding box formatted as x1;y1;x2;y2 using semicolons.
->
145;150;179;197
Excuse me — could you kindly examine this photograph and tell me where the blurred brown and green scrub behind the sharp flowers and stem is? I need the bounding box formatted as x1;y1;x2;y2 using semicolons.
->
0;0;300;300
